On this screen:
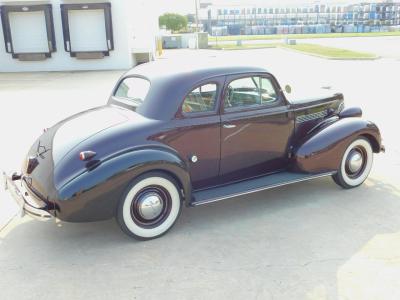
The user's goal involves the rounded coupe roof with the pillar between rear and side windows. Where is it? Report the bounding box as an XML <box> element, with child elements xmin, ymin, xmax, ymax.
<box><xmin>117</xmin><ymin>60</ymin><xmax>268</xmax><ymax>120</ymax></box>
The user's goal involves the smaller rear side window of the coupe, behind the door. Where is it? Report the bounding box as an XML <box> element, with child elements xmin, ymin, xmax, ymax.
<box><xmin>182</xmin><ymin>83</ymin><xmax>217</xmax><ymax>114</ymax></box>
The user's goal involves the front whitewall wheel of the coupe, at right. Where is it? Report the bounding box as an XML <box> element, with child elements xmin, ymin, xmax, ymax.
<box><xmin>333</xmin><ymin>137</ymin><xmax>374</xmax><ymax>189</ymax></box>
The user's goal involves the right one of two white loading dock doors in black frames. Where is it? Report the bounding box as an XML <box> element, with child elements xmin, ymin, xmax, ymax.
<box><xmin>68</xmin><ymin>9</ymin><xmax>108</xmax><ymax>52</ymax></box>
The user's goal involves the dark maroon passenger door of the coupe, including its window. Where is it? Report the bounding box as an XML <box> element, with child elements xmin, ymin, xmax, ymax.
<box><xmin>220</xmin><ymin>73</ymin><xmax>294</xmax><ymax>183</ymax></box>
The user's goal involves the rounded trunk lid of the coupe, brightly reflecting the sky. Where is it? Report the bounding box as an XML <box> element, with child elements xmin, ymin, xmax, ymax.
<box><xmin>22</xmin><ymin>106</ymin><xmax>129</xmax><ymax>204</ymax></box>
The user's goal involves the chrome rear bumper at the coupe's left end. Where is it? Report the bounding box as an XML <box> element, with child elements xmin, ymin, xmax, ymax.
<box><xmin>0</xmin><ymin>172</ymin><xmax>53</xmax><ymax>221</ymax></box>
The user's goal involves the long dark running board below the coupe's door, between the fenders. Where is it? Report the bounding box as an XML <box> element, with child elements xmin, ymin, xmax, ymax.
<box><xmin>190</xmin><ymin>172</ymin><xmax>336</xmax><ymax>206</ymax></box>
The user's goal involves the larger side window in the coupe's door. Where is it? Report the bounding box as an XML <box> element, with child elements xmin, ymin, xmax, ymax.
<box><xmin>224</xmin><ymin>76</ymin><xmax>278</xmax><ymax>110</ymax></box>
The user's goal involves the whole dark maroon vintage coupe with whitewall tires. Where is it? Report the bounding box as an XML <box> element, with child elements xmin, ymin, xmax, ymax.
<box><xmin>4</xmin><ymin>63</ymin><xmax>384</xmax><ymax>239</ymax></box>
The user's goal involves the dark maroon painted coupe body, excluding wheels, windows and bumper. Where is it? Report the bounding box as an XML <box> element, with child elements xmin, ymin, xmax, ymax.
<box><xmin>5</xmin><ymin>64</ymin><xmax>382</xmax><ymax>222</ymax></box>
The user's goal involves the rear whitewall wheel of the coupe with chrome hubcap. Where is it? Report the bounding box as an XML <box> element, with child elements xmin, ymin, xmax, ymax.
<box><xmin>117</xmin><ymin>172</ymin><xmax>182</xmax><ymax>240</ymax></box>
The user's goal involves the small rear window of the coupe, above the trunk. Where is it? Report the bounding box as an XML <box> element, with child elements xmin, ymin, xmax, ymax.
<box><xmin>114</xmin><ymin>77</ymin><xmax>150</xmax><ymax>106</ymax></box>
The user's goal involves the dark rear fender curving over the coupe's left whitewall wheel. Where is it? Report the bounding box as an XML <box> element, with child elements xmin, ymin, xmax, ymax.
<box><xmin>56</xmin><ymin>147</ymin><xmax>191</xmax><ymax>222</ymax></box>
